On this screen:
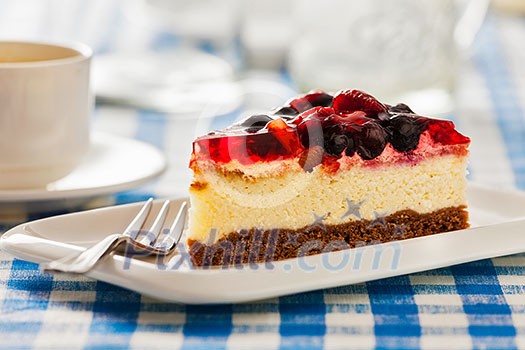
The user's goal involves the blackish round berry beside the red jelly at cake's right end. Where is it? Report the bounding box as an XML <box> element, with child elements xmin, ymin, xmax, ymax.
<box><xmin>387</xmin><ymin>114</ymin><xmax>427</xmax><ymax>152</ymax></box>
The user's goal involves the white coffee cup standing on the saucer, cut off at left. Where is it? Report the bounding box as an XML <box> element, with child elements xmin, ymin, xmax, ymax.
<box><xmin>0</xmin><ymin>41</ymin><xmax>92</xmax><ymax>190</ymax></box>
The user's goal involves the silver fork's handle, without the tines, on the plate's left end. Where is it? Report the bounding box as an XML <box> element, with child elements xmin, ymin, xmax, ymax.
<box><xmin>40</xmin><ymin>233</ymin><xmax>126</xmax><ymax>273</ymax></box>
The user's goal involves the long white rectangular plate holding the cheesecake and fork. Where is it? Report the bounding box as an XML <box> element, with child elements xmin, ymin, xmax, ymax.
<box><xmin>0</xmin><ymin>185</ymin><xmax>525</xmax><ymax>304</ymax></box>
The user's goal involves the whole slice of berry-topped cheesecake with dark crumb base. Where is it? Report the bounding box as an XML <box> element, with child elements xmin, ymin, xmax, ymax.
<box><xmin>188</xmin><ymin>90</ymin><xmax>470</xmax><ymax>266</ymax></box>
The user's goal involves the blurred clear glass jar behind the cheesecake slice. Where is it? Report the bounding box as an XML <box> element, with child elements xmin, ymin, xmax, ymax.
<box><xmin>288</xmin><ymin>0</ymin><xmax>489</xmax><ymax>114</ymax></box>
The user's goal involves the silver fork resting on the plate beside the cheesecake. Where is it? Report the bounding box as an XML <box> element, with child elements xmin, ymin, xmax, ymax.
<box><xmin>41</xmin><ymin>198</ymin><xmax>187</xmax><ymax>273</ymax></box>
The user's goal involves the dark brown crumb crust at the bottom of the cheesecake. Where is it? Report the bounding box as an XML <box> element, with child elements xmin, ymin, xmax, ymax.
<box><xmin>188</xmin><ymin>206</ymin><xmax>469</xmax><ymax>266</ymax></box>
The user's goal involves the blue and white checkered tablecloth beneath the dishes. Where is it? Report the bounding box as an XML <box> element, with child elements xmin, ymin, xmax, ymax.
<box><xmin>0</xmin><ymin>2</ymin><xmax>525</xmax><ymax>349</ymax></box>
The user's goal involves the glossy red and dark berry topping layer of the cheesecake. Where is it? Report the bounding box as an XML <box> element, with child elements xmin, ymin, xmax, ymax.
<box><xmin>192</xmin><ymin>90</ymin><xmax>470</xmax><ymax>171</ymax></box>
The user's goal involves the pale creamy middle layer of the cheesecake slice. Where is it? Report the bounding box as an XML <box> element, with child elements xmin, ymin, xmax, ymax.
<box><xmin>188</xmin><ymin>155</ymin><xmax>467</xmax><ymax>243</ymax></box>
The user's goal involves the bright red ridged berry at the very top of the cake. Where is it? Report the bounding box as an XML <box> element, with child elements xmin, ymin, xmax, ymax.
<box><xmin>333</xmin><ymin>90</ymin><xmax>387</xmax><ymax>118</ymax></box>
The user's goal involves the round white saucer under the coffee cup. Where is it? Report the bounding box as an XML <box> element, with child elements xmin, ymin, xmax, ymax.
<box><xmin>0</xmin><ymin>132</ymin><xmax>166</xmax><ymax>204</ymax></box>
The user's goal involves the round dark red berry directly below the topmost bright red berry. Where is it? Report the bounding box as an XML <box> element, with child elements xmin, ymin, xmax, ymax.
<box><xmin>354</xmin><ymin>121</ymin><xmax>388</xmax><ymax>160</ymax></box>
